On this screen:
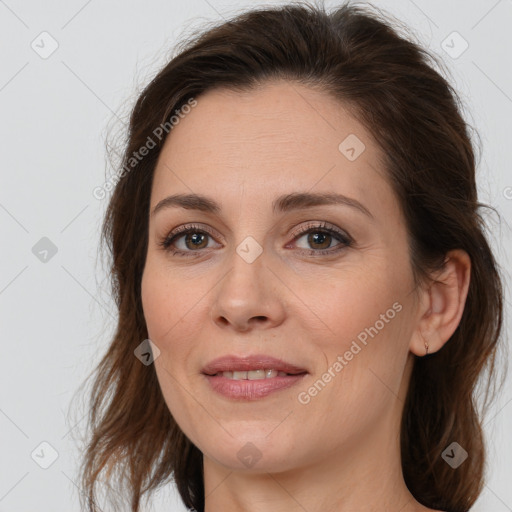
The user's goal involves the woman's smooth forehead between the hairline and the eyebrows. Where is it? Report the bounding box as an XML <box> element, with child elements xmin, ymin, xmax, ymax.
<box><xmin>151</xmin><ymin>81</ymin><xmax>393</xmax><ymax>217</ymax></box>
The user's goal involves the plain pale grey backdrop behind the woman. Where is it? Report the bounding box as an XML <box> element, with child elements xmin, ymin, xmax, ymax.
<box><xmin>0</xmin><ymin>0</ymin><xmax>512</xmax><ymax>512</ymax></box>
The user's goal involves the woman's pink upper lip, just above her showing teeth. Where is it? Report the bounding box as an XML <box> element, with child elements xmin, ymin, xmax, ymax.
<box><xmin>202</xmin><ymin>354</ymin><xmax>307</xmax><ymax>375</ymax></box>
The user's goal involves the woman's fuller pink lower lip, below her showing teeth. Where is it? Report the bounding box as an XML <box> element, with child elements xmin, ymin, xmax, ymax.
<box><xmin>205</xmin><ymin>373</ymin><xmax>307</xmax><ymax>400</ymax></box>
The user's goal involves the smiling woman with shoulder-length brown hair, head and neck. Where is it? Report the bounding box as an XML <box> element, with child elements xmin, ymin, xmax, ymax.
<box><xmin>78</xmin><ymin>4</ymin><xmax>502</xmax><ymax>512</ymax></box>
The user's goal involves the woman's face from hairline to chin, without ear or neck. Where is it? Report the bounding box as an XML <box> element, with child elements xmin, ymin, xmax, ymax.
<box><xmin>142</xmin><ymin>81</ymin><xmax>418</xmax><ymax>472</ymax></box>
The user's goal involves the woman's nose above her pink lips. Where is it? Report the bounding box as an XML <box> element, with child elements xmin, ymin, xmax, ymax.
<box><xmin>211</xmin><ymin>243</ymin><xmax>286</xmax><ymax>332</ymax></box>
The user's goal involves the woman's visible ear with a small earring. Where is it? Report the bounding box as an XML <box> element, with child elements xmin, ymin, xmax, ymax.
<box><xmin>409</xmin><ymin>249</ymin><xmax>471</xmax><ymax>356</ymax></box>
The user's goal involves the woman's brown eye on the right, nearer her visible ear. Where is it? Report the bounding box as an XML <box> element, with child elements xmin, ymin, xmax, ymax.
<box><xmin>288</xmin><ymin>222</ymin><xmax>353</xmax><ymax>256</ymax></box>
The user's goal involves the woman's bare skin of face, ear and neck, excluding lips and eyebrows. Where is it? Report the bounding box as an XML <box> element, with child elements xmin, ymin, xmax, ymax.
<box><xmin>142</xmin><ymin>81</ymin><xmax>470</xmax><ymax>512</ymax></box>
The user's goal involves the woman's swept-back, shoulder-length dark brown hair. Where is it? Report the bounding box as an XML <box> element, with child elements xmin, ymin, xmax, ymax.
<box><xmin>76</xmin><ymin>3</ymin><xmax>503</xmax><ymax>512</ymax></box>
